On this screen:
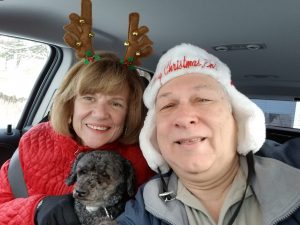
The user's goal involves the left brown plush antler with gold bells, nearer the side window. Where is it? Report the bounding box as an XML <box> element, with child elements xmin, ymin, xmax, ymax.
<box><xmin>64</xmin><ymin>0</ymin><xmax>94</xmax><ymax>58</ymax></box>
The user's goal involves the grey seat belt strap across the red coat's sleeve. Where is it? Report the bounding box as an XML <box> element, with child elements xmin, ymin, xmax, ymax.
<box><xmin>8</xmin><ymin>148</ymin><xmax>28</xmax><ymax>198</ymax></box>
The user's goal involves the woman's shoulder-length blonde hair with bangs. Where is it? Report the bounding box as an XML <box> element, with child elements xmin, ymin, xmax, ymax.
<box><xmin>50</xmin><ymin>52</ymin><xmax>146</xmax><ymax>144</ymax></box>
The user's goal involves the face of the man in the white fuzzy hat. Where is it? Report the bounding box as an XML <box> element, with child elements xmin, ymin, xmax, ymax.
<box><xmin>156</xmin><ymin>74</ymin><xmax>236</xmax><ymax>179</ymax></box>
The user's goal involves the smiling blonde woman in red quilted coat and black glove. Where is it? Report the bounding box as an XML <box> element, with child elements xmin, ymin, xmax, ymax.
<box><xmin>0</xmin><ymin>53</ymin><xmax>152</xmax><ymax>225</ymax></box>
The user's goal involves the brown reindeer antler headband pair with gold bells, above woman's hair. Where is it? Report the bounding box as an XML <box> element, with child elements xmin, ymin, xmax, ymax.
<box><xmin>64</xmin><ymin>0</ymin><xmax>153</xmax><ymax>68</ymax></box>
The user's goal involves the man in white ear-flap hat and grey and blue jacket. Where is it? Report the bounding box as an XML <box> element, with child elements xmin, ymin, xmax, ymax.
<box><xmin>117</xmin><ymin>44</ymin><xmax>300</xmax><ymax>225</ymax></box>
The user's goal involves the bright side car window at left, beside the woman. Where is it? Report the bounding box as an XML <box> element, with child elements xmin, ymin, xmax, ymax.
<box><xmin>0</xmin><ymin>35</ymin><xmax>51</xmax><ymax>128</ymax></box>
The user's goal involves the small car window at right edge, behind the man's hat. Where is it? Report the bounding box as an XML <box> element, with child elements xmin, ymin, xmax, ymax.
<box><xmin>252</xmin><ymin>99</ymin><xmax>300</xmax><ymax>129</ymax></box>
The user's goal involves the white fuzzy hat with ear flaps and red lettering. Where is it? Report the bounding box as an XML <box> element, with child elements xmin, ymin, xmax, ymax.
<box><xmin>140</xmin><ymin>43</ymin><xmax>266</xmax><ymax>173</ymax></box>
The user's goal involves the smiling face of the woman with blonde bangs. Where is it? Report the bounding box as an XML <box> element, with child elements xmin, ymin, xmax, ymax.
<box><xmin>72</xmin><ymin>90</ymin><xmax>129</xmax><ymax>148</ymax></box>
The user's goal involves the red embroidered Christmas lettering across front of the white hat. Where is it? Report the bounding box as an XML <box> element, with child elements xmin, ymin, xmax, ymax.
<box><xmin>156</xmin><ymin>56</ymin><xmax>217</xmax><ymax>80</ymax></box>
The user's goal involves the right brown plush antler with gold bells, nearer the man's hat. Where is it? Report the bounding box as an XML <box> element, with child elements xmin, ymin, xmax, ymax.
<box><xmin>124</xmin><ymin>12</ymin><xmax>153</xmax><ymax>66</ymax></box>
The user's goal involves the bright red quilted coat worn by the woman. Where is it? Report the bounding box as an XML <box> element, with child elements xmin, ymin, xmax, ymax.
<box><xmin>0</xmin><ymin>122</ymin><xmax>153</xmax><ymax>225</ymax></box>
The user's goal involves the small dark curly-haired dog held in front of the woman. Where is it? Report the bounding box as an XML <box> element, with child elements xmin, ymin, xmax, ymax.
<box><xmin>66</xmin><ymin>150</ymin><xmax>135</xmax><ymax>225</ymax></box>
